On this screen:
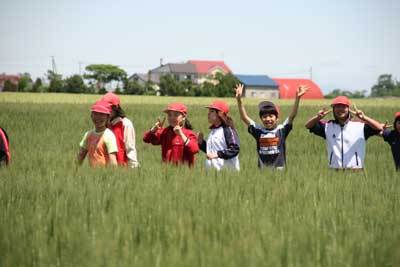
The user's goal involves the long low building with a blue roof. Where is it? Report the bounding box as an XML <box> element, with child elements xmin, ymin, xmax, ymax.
<box><xmin>235</xmin><ymin>74</ymin><xmax>279</xmax><ymax>99</ymax></box>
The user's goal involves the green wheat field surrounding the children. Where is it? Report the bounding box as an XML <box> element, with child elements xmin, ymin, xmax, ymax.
<box><xmin>0</xmin><ymin>93</ymin><xmax>400</xmax><ymax>266</ymax></box>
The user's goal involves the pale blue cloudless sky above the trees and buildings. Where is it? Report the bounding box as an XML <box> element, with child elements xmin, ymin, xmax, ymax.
<box><xmin>0</xmin><ymin>0</ymin><xmax>400</xmax><ymax>92</ymax></box>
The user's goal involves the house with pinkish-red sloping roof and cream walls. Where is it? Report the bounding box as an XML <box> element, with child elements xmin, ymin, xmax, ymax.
<box><xmin>188</xmin><ymin>60</ymin><xmax>232</xmax><ymax>84</ymax></box>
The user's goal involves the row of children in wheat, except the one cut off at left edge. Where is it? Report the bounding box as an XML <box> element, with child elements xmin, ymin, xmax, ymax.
<box><xmin>77</xmin><ymin>87</ymin><xmax>400</xmax><ymax>171</ymax></box>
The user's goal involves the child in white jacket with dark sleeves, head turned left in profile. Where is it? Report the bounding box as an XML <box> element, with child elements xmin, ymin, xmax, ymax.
<box><xmin>198</xmin><ymin>100</ymin><xmax>240</xmax><ymax>171</ymax></box>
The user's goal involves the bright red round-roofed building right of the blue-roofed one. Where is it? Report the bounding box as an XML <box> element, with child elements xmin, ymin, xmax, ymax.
<box><xmin>272</xmin><ymin>78</ymin><xmax>324</xmax><ymax>99</ymax></box>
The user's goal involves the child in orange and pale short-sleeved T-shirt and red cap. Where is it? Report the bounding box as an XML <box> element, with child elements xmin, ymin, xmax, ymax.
<box><xmin>77</xmin><ymin>101</ymin><xmax>118</xmax><ymax>167</ymax></box>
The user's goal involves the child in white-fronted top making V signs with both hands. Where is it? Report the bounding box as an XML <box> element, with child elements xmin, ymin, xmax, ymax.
<box><xmin>306</xmin><ymin>96</ymin><xmax>382</xmax><ymax>170</ymax></box>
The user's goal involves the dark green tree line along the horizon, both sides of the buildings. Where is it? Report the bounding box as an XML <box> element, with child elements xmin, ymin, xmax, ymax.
<box><xmin>3</xmin><ymin>64</ymin><xmax>400</xmax><ymax>98</ymax></box>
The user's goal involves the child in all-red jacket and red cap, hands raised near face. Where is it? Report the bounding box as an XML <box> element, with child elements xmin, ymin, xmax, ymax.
<box><xmin>143</xmin><ymin>103</ymin><xmax>199</xmax><ymax>166</ymax></box>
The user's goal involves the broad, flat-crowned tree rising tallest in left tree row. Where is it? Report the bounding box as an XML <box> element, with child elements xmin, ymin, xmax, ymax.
<box><xmin>83</xmin><ymin>64</ymin><xmax>127</xmax><ymax>91</ymax></box>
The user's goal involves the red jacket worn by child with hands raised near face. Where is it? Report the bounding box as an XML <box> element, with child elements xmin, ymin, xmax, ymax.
<box><xmin>143</xmin><ymin>127</ymin><xmax>199</xmax><ymax>166</ymax></box>
